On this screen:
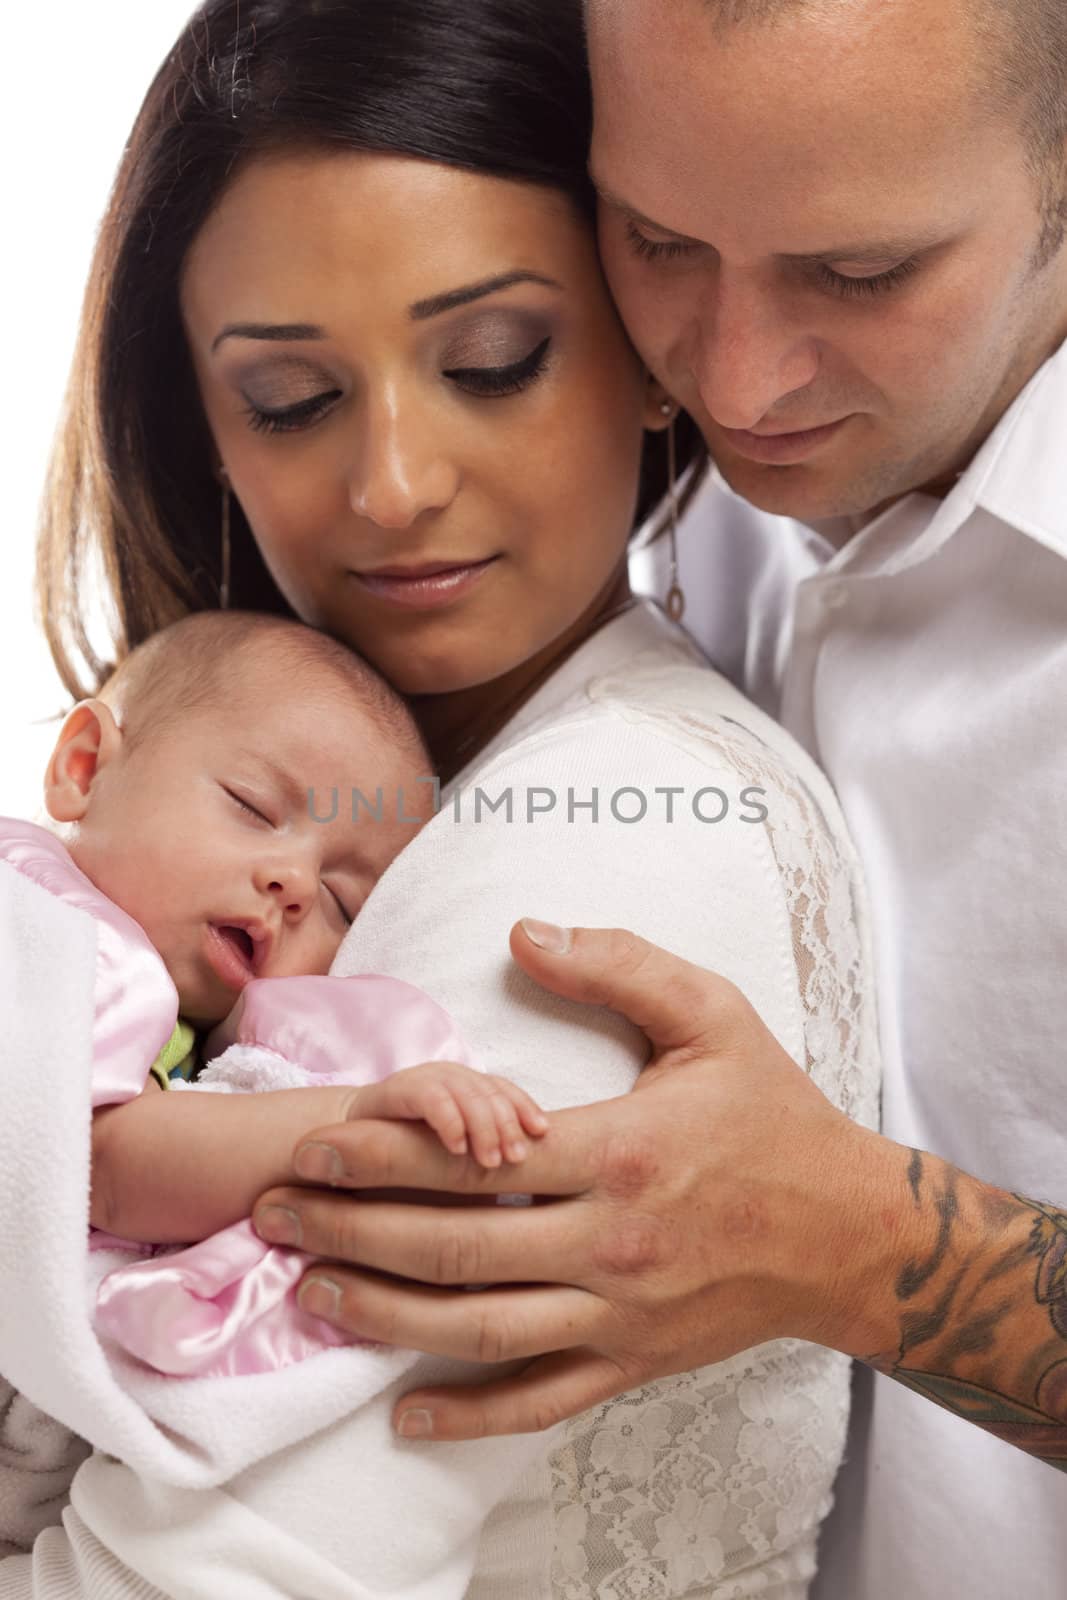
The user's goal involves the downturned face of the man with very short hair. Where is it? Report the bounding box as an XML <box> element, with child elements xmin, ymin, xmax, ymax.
<box><xmin>589</xmin><ymin>0</ymin><xmax>1067</xmax><ymax>520</ymax></box>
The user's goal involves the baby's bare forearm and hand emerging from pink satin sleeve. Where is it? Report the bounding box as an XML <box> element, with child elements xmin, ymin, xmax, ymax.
<box><xmin>90</xmin><ymin>1064</ymin><xmax>547</xmax><ymax>1245</ymax></box>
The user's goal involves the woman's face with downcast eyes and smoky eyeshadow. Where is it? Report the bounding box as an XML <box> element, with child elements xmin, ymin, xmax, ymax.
<box><xmin>182</xmin><ymin>154</ymin><xmax>662</xmax><ymax>694</ymax></box>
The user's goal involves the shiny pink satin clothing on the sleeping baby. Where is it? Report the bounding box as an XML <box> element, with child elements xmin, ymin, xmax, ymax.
<box><xmin>0</xmin><ymin>818</ymin><xmax>469</xmax><ymax>1378</ymax></box>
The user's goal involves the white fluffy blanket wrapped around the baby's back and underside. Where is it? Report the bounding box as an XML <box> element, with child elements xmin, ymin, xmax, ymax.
<box><xmin>0</xmin><ymin>866</ymin><xmax>425</xmax><ymax>1488</ymax></box>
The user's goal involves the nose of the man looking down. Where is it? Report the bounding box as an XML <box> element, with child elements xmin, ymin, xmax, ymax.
<box><xmin>689</xmin><ymin>267</ymin><xmax>819</xmax><ymax>429</ymax></box>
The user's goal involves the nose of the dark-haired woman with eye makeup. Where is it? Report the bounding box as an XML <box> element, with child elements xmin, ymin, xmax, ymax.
<box><xmin>349</xmin><ymin>397</ymin><xmax>459</xmax><ymax>531</ymax></box>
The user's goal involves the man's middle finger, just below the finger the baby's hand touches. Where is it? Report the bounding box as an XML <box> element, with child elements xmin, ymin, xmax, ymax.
<box><xmin>253</xmin><ymin>1189</ymin><xmax>584</xmax><ymax>1286</ymax></box>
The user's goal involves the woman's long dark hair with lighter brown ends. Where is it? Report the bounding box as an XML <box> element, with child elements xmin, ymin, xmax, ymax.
<box><xmin>38</xmin><ymin>0</ymin><xmax>704</xmax><ymax>696</ymax></box>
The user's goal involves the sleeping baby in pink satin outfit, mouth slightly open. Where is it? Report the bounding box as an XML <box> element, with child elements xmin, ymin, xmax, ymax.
<box><xmin>0</xmin><ymin>613</ymin><xmax>547</xmax><ymax>1555</ymax></box>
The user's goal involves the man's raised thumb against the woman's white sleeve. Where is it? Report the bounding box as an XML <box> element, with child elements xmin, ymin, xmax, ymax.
<box><xmin>510</xmin><ymin>918</ymin><xmax>741</xmax><ymax>1053</ymax></box>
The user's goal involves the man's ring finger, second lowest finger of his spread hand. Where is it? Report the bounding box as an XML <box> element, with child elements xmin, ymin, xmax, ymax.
<box><xmin>299</xmin><ymin>1262</ymin><xmax>603</xmax><ymax>1363</ymax></box>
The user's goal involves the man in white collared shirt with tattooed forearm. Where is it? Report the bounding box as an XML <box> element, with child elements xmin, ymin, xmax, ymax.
<box><xmin>258</xmin><ymin>0</ymin><xmax>1067</xmax><ymax>1600</ymax></box>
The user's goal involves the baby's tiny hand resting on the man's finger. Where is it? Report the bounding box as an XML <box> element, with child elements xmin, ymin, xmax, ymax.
<box><xmin>349</xmin><ymin>1062</ymin><xmax>549</xmax><ymax>1166</ymax></box>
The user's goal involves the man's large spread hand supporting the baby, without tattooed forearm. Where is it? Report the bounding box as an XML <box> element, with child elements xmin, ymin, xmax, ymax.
<box><xmin>254</xmin><ymin>923</ymin><xmax>907</xmax><ymax>1438</ymax></box>
